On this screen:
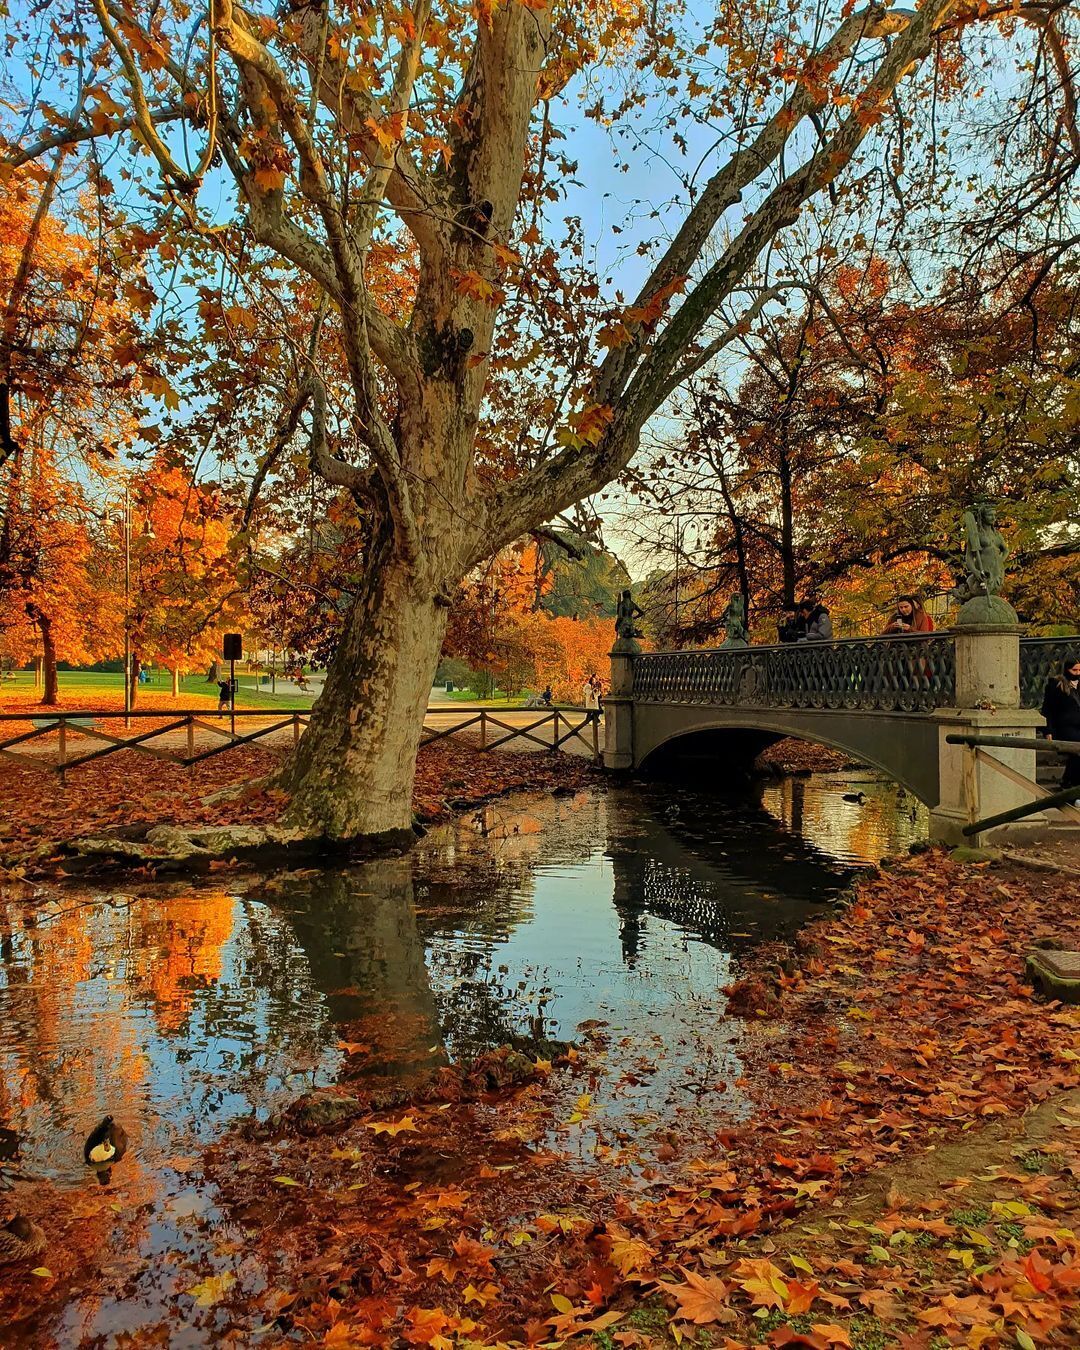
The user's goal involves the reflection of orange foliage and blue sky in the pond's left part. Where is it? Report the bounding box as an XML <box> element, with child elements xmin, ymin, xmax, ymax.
<box><xmin>0</xmin><ymin>891</ymin><xmax>340</xmax><ymax>1180</ymax></box>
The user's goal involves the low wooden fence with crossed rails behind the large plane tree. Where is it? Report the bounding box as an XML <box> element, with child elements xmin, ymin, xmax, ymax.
<box><xmin>0</xmin><ymin>705</ymin><xmax>601</xmax><ymax>779</ymax></box>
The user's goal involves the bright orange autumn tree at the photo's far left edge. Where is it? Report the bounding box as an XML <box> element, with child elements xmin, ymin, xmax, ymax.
<box><xmin>0</xmin><ymin>162</ymin><xmax>147</xmax><ymax>703</ymax></box>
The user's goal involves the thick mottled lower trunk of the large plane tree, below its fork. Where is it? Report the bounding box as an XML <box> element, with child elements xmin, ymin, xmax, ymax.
<box><xmin>278</xmin><ymin>545</ymin><xmax>447</xmax><ymax>844</ymax></box>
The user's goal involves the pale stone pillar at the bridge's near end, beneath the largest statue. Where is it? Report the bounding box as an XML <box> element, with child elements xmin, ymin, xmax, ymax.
<box><xmin>930</xmin><ymin>621</ymin><xmax>1046</xmax><ymax>845</ymax></box>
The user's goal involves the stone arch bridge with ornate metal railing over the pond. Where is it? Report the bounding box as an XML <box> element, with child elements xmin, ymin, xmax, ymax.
<box><xmin>605</xmin><ymin>628</ymin><xmax>1076</xmax><ymax>841</ymax></box>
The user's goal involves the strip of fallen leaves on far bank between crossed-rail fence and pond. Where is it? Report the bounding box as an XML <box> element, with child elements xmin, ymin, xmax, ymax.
<box><xmin>0</xmin><ymin>738</ymin><xmax>598</xmax><ymax>876</ymax></box>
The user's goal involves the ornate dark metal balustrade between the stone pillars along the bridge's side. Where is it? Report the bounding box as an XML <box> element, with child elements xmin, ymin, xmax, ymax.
<box><xmin>633</xmin><ymin>633</ymin><xmax>956</xmax><ymax>713</ymax></box>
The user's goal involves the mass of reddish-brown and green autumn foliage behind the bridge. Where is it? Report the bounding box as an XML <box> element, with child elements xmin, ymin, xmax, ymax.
<box><xmin>636</xmin><ymin>257</ymin><xmax>1080</xmax><ymax>639</ymax></box>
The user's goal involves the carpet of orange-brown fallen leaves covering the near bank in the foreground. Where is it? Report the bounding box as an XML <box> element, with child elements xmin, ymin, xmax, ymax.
<box><xmin>0</xmin><ymin>852</ymin><xmax>1080</xmax><ymax>1350</ymax></box>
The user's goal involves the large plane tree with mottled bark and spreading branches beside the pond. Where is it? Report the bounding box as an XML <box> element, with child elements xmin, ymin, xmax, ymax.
<box><xmin>8</xmin><ymin>0</ymin><xmax>1076</xmax><ymax>838</ymax></box>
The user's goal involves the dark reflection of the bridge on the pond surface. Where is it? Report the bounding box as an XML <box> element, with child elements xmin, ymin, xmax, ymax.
<box><xmin>606</xmin><ymin>788</ymin><xmax>848</xmax><ymax>967</ymax></box>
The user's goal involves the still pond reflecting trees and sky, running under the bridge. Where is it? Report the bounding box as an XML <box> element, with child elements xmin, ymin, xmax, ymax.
<box><xmin>0</xmin><ymin>775</ymin><xmax>925</xmax><ymax>1345</ymax></box>
